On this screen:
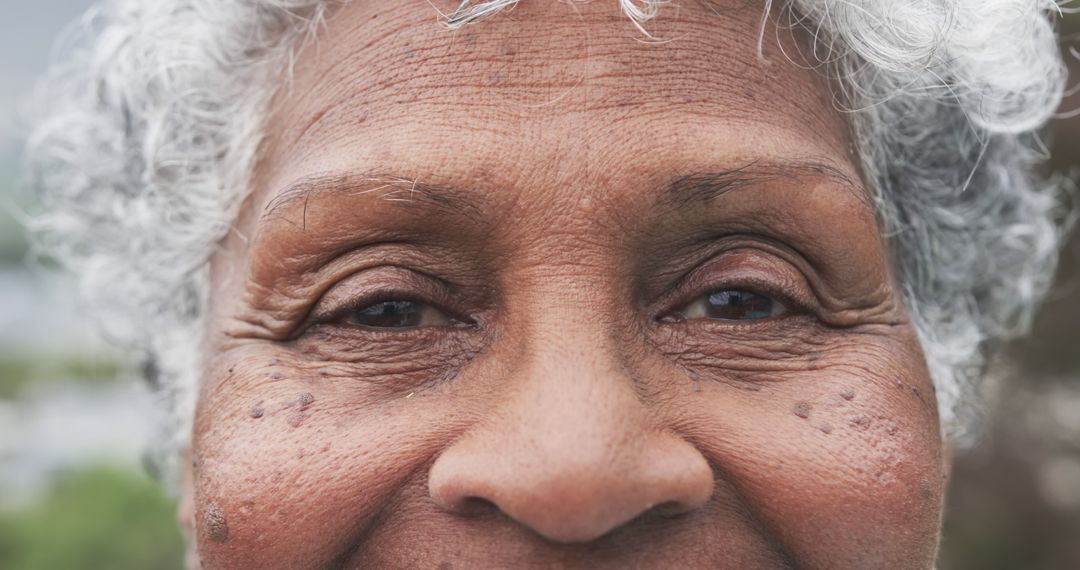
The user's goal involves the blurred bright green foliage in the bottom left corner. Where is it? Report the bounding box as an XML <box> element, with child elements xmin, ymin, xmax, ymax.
<box><xmin>0</xmin><ymin>467</ymin><xmax>184</xmax><ymax>570</ymax></box>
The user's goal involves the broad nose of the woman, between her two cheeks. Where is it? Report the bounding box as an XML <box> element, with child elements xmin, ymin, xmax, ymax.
<box><xmin>428</xmin><ymin>338</ymin><xmax>714</xmax><ymax>543</ymax></box>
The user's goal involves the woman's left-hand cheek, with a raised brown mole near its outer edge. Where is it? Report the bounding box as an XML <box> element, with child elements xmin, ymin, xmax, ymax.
<box><xmin>192</xmin><ymin>352</ymin><xmax>449</xmax><ymax>568</ymax></box>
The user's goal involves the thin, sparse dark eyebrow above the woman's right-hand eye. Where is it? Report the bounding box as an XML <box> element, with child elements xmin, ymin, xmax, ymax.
<box><xmin>661</xmin><ymin>161</ymin><xmax>872</xmax><ymax>209</ymax></box>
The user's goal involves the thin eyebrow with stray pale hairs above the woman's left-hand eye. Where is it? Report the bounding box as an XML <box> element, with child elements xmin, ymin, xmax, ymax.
<box><xmin>260</xmin><ymin>173</ymin><xmax>482</xmax><ymax>229</ymax></box>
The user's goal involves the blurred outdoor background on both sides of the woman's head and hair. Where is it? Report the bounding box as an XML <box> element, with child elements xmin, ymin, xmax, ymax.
<box><xmin>0</xmin><ymin>0</ymin><xmax>1080</xmax><ymax>570</ymax></box>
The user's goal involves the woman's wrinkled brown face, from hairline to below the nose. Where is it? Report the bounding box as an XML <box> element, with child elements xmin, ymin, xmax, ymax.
<box><xmin>186</xmin><ymin>0</ymin><xmax>946</xmax><ymax>569</ymax></box>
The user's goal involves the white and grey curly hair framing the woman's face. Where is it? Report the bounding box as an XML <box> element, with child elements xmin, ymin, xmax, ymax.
<box><xmin>28</xmin><ymin>0</ymin><xmax>1066</xmax><ymax>479</ymax></box>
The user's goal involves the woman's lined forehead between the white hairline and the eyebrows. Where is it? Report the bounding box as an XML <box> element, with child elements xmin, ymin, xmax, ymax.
<box><xmin>259</xmin><ymin>0</ymin><xmax>858</xmax><ymax>201</ymax></box>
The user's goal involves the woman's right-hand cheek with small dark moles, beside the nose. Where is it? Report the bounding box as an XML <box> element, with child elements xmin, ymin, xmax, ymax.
<box><xmin>678</xmin><ymin>336</ymin><xmax>945</xmax><ymax>568</ymax></box>
